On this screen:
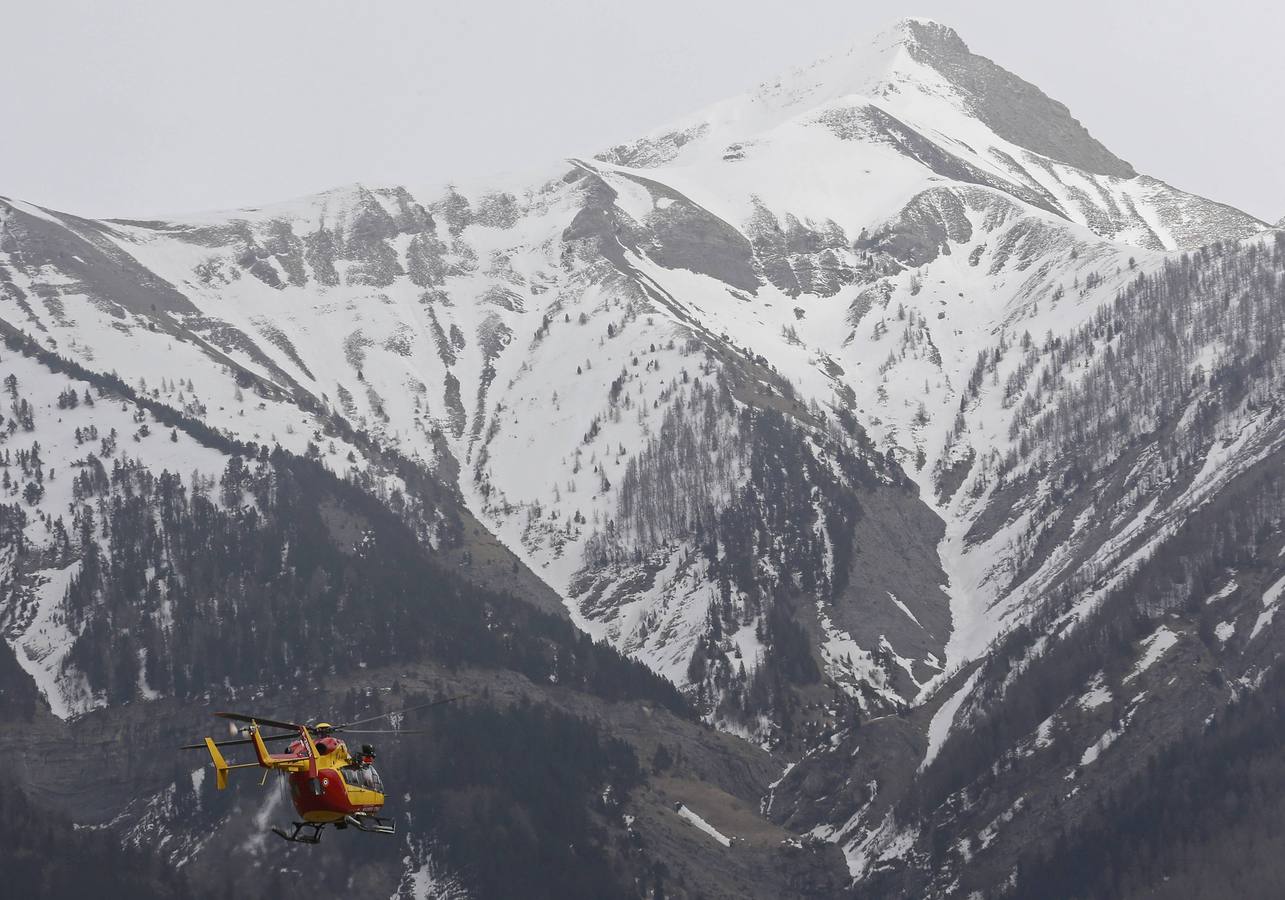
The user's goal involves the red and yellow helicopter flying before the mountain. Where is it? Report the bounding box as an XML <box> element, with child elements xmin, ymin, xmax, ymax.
<box><xmin>180</xmin><ymin>697</ymin><xmax>463</xmax><ymax>843</ymax></box>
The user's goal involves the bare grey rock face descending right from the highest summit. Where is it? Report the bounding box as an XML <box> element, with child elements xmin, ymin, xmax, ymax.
<box><xmin>907</xmin><ymin>22</ymin><xmax>1137</xmax><ymax>179</ymax></box>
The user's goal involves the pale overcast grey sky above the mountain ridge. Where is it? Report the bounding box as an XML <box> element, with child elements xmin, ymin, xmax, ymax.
<box><xmin>0</xmin><ymin>0</ymin><xmax>1285</xmax><ymax>221</ymax></box>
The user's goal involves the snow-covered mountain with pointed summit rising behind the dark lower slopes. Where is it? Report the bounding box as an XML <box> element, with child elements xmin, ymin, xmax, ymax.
<box><xmin>0</xmin><ymin>19</ymin><xmax>1285</xmax><ymax>892</ymax></box>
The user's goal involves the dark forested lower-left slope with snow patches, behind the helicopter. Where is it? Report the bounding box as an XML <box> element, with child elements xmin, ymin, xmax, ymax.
<box><xmin>0</xmin><ymin>337</ymin><xmax>840</xmax><ymax>896</ymax></box>
